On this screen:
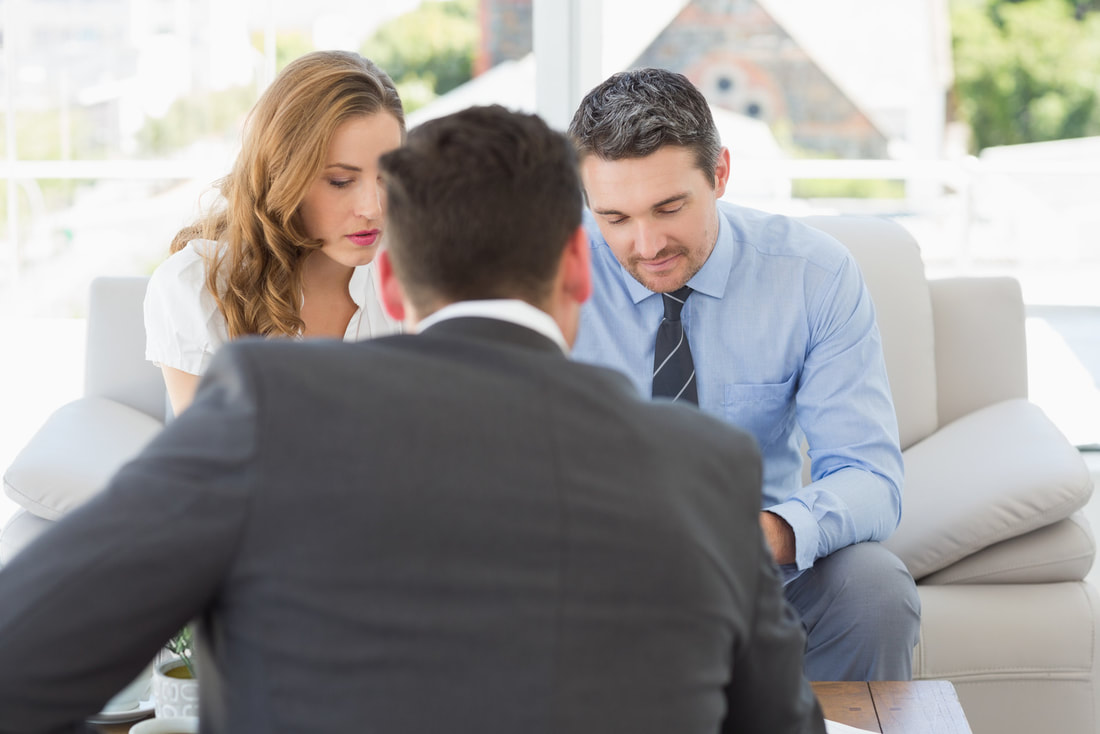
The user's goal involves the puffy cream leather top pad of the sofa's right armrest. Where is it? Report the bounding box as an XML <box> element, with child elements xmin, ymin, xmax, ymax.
<box><xmin>886</xmin><ymin>399</ymin><xmax>1092</xmax><ymax>579</ymax></box>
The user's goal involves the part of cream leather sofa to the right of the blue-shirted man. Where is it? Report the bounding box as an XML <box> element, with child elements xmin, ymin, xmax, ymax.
<box><xmin>805</xmin><ymin>217</ymin><xmax>1100</xmax><ymax>734</ymax></box>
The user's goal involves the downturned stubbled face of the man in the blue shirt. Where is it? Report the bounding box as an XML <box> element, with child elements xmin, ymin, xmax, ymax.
<box><xmin>581</xmin><ymin>145</ymin><xmax>729</xmax><ymax>293</ymax></box>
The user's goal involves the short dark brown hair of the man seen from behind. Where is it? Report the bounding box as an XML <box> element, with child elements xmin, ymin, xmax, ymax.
<box><xmin>380</xmin><ymin>106</ymin><xmax>583</xmax><ymax>315</ymax></box>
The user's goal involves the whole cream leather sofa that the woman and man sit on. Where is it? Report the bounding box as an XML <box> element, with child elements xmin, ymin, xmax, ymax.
<box><xmin>0</xmin><ymin>217</ymin><xmax>1100</xmax><ymax>734</ymax></box>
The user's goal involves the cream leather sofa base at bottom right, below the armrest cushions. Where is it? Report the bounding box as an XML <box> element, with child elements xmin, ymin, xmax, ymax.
<box><xmin>913</xmin><ymin>581</ymin><xmax>1100</xmax><ymax>732</ymax></box>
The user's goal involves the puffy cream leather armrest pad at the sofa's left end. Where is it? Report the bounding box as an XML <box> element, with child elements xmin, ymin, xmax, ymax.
<box><xmin>3</xmin><ymin>397</ymin><xmax>163</xmax><ymax>519</ymax></box>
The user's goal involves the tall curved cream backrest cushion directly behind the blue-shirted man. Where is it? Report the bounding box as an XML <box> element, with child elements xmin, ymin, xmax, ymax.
<box><xmin>802</xmin><ymin>216</ymin><xmax>939</xmax><ymax>449</ymax></box>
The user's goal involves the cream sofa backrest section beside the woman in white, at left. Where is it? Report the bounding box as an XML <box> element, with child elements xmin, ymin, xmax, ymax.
<box><xmin>84</xmin><ymin>276</ymin><xmax>166</xmax><ymax>420</ymax></box>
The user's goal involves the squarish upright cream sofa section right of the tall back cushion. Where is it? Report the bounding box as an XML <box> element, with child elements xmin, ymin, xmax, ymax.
<box><xmin>928</xmin><ymin>277</ymin><xmax>1027</xmax><ymax>426</ymax></box>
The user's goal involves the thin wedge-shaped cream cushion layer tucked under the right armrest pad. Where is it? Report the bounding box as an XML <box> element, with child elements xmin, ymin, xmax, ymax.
<box><xmin>921</xmin><ymin>512</ymin><xmax>1096</xmax><ymax>584</ymax></box>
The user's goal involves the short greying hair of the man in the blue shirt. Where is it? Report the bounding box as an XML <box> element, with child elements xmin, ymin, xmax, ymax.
<box><xmin>569</xmin><ymin>68</ymin><xmax>722</xmax><ymax>177</ymax></box>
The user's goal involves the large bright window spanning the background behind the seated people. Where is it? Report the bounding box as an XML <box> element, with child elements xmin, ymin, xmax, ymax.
<box><xmin>0</xmin><ymin>0</ymin><xmax>1100</xmax><ymax>517</ymax></box>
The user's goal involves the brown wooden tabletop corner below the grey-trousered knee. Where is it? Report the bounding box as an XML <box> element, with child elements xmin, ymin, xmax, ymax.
<box><xmin>812</xmin><ymin>680</ymin><xmax>971</xmax><ymax>734</ymax></box>
